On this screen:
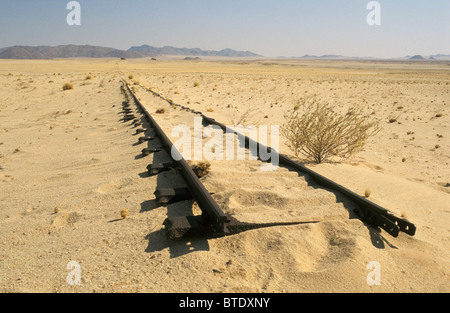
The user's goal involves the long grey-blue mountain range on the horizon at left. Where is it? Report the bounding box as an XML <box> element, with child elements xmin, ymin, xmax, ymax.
<box><xmin>0</xmin><ymin>45</ymin><xmax>260</xmax><ymax>59</ymax></box>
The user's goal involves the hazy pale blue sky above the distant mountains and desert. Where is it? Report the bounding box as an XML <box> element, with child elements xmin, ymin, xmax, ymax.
<box><xmin>0</xmin><ymin>0</ymin><xmax>450</xmax><ymax>57</ymax></box>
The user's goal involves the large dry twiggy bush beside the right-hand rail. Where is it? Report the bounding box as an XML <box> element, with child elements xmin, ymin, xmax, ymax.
<box><xmin>281</xmin><ymin>96</ymin><xmax>380</xmax><ymax>163</ymax></box>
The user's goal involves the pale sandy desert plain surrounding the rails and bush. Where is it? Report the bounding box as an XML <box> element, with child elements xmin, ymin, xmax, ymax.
<box><xmin>0</xmin><ymin>59</ymin><xmax>450</xmax><ymax>293</ymax></box>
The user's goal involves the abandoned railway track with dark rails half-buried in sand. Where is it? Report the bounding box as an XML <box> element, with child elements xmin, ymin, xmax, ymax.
<box><xmin>121</xmin><ymin>81</ymin><xmax>416</xmax><ymax>239</ymax></box>
